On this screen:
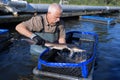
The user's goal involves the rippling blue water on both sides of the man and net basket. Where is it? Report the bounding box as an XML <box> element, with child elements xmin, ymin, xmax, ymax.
<box><xmin>0</xmin><ymin>20</ymin><xmax>120</xmax><ymax>80</ymax></box>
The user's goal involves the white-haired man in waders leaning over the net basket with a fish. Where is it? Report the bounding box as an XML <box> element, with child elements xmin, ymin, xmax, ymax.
<box><xmin>16</xmin><ymin>3</ymin><xmax>66</xmax><ymax>54</ymax></box>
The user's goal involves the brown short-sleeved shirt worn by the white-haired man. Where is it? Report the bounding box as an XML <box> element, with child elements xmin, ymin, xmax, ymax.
<box><xmin>22</xmin><ymin>15</ymin><xmax>65</xmax><ymax>38</ymax></box>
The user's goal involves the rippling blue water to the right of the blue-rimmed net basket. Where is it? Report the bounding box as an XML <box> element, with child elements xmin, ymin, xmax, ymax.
<box><xmin>67</xmin><ymin>19</ymin><xmax>120</xmax><ymax>80</ymax></box>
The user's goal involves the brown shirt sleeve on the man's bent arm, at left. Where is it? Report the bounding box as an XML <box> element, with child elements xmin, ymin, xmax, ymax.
<box><xmin>22</xmin><ymin>16</ymin><xmax>43</xmax><ymax>31</ymax></box>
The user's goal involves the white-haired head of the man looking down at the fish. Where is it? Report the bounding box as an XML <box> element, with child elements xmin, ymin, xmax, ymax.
<box><xmin>47</xmin><ymin>3</ymin><xmax>62</xmax><ymax>25</ymax></box>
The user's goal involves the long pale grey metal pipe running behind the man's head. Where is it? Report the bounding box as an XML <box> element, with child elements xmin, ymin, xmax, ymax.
<box><xmin>26</xmin><ymin>4</ymin><xmax>120</xmax><ymax>12</ymax></box>
